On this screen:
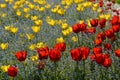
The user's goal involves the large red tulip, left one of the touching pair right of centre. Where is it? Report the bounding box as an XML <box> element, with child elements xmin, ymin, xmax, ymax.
<box><xmin>70</xmin><ymin>48</ymin><xmax>82</xmax><ymax>61</ymax></box>
